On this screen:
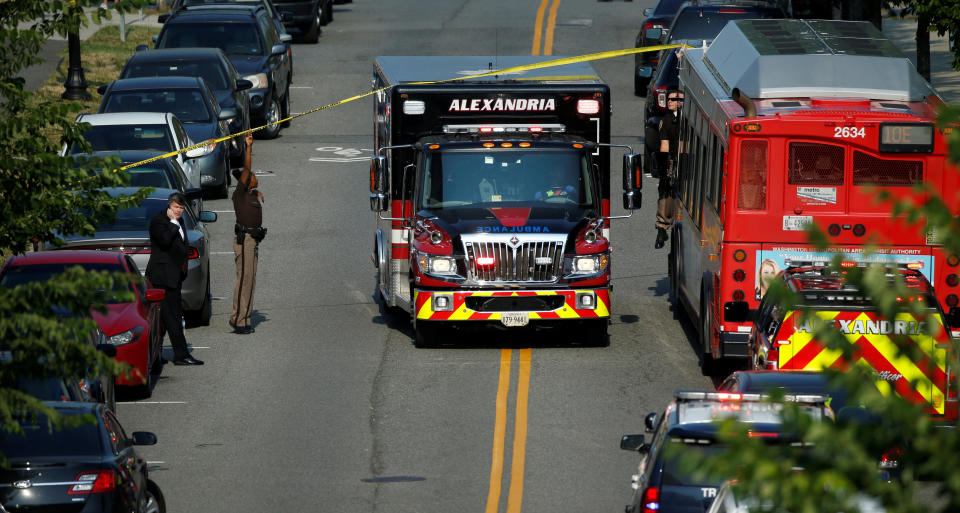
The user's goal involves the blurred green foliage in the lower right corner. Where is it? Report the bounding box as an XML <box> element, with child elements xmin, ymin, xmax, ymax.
<box><xmin>686</xmin><ymin>106</ymin><xmax>960</xmax><ymax>513</ymax></box>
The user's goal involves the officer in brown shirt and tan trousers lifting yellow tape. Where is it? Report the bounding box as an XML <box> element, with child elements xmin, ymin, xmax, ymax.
<box><xmin>230</xmin><ymin>132</ymin><xmax>267</xmax><ymax>335</ymax></box>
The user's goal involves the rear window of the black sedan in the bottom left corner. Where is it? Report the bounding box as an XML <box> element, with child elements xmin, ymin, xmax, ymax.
<box><xmin>0</xmin><ymin>412</ymin><xmax>102</xmax><ymax>459</ymax></box>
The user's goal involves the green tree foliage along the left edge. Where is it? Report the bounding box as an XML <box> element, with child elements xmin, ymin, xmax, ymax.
<box><xmin>0</xmin><ymin>0</ymin><xmax>147</xmax><ymax>430</ymax></box>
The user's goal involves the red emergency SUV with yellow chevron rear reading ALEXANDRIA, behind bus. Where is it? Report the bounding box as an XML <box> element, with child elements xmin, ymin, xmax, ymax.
<box><xmin>749</xmin><ymin>262</ymin><xmax>957</xmax><ymax>420</ymax></box>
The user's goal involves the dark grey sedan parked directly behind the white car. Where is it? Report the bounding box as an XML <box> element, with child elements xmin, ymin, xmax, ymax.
<box><xmin>97</xmin><ymin>76</ymin><xmax>238</xmax><ymax>198</ymax></box>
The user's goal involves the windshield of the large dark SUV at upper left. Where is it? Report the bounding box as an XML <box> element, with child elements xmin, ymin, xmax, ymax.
<box><xmin>157</xmin><ymin>21</ymin><xmax>264</xmax><ymax>55</ymax></box>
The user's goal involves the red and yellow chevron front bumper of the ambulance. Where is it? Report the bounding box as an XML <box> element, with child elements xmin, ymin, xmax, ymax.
<box><xmin>414</xmin><ymin>288</ymin><xmax>610</xmax><ymax>327</ymax></box>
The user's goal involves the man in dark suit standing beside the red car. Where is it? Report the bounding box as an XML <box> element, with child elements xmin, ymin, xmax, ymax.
<box><xmin>147</xmin><ymin>192</ymin><xmax>203</xmax><ymax>365</ymax></box>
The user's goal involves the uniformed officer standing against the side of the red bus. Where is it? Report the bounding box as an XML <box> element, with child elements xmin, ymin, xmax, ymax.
<box><xmin>653</xmin><ymin>91</ymin><xmax>683</xmax><ymax>249</ymax></box>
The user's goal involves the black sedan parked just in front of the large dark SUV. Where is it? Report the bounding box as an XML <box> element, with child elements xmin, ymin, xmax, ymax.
<box><xmin>119</xmin><ymin>45</ymin><xmax>253</xmax><ymax>165</ymax></box>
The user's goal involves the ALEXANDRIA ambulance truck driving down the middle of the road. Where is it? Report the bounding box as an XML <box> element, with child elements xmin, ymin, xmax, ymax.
<box><xmin>370</xmin><ymin>57</ymin><xmax>641</xmax><ymax>347</ymax></box>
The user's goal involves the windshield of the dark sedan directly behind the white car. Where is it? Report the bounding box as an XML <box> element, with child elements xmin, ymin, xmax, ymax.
<box><xmin>100</xmin><ymin>89</ymin><xmax>212</xmax><ymax>123</ymax></box>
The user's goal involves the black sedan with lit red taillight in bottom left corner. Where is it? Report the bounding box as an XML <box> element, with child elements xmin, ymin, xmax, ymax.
<box><xmin>0</xmin><ymin>402</ymin><xmax>166</xmax><ymax>513</ymax></box>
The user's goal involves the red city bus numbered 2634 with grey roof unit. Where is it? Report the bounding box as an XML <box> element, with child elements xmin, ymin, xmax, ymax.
<box><xmin>669</xmin><ymin>20</ymin><xmax>960</xmax><ymax>372</ymax></box>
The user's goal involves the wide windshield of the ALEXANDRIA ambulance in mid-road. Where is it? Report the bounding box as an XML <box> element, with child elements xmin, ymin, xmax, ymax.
<box><xmin>419</xmin><ymin>149</ymin><xmax>596</xmax><ymax>209</ymax></box>
